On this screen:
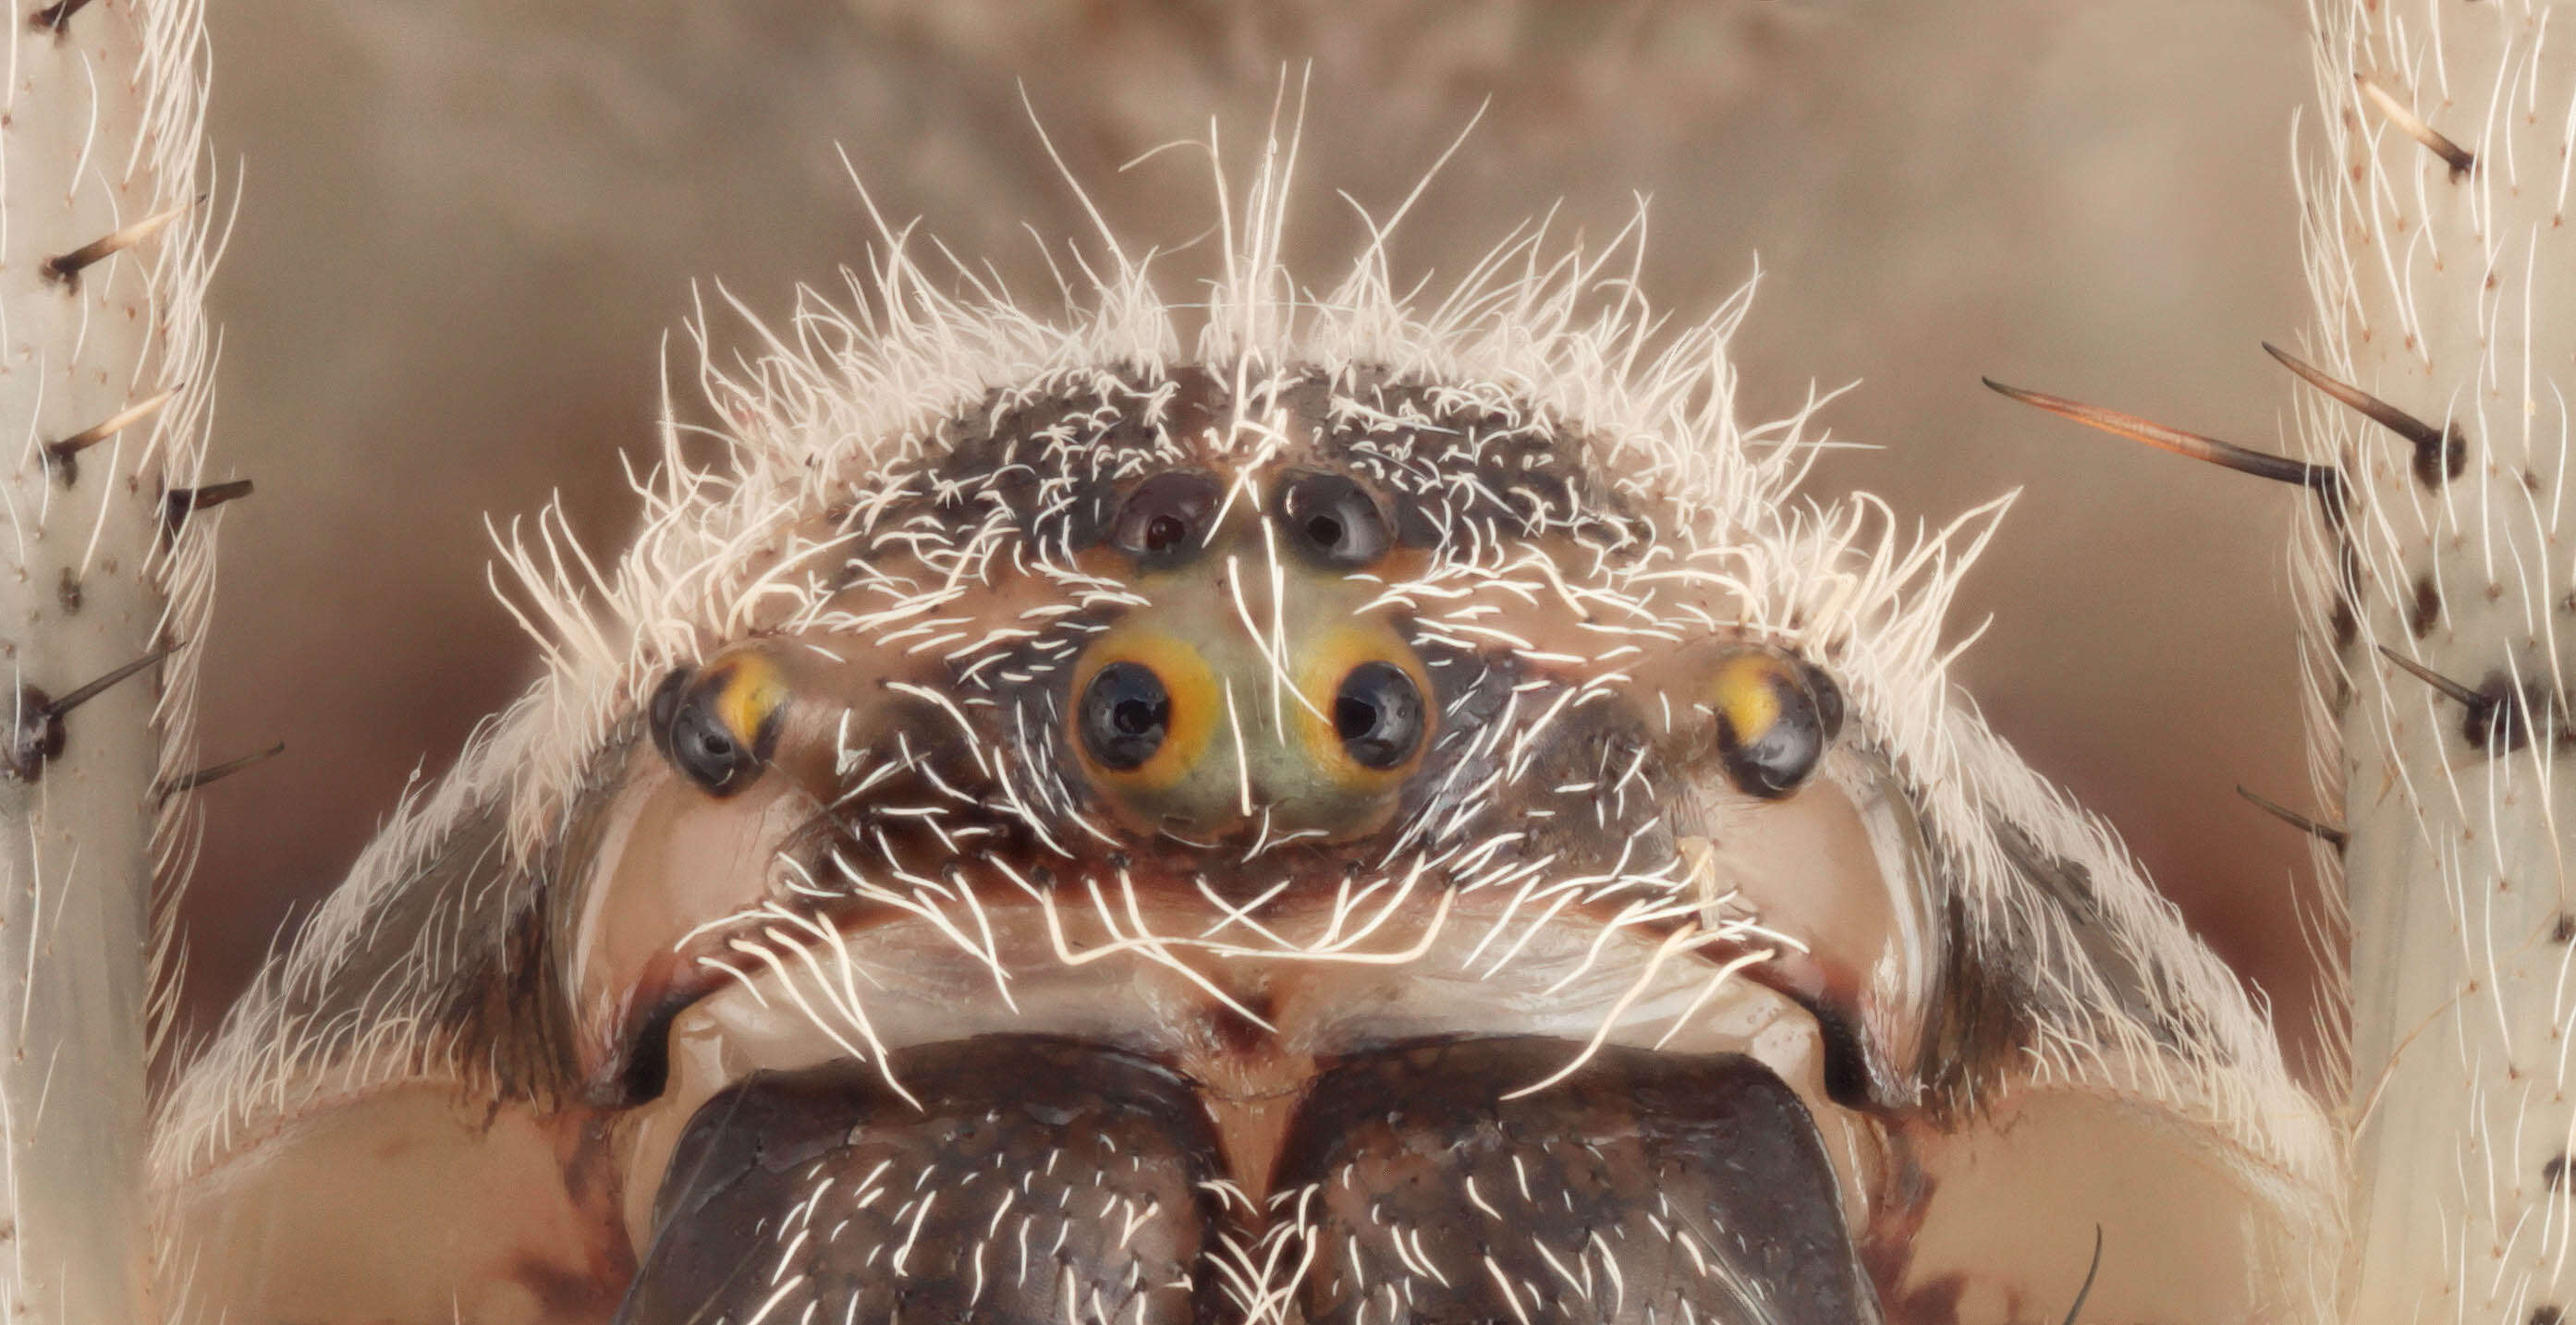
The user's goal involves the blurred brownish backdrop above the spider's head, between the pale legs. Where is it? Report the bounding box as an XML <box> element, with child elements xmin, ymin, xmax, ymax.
<box><xmin>186</xmin><ymin>0</ymin><xmax>2314</xmax><ymax>1080</ymax></box>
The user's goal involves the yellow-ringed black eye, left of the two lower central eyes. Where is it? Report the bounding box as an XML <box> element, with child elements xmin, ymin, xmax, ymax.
<box><xmin>1069</xmin><ymin>627</ymin><xmax>1224</xmax><ymax>793</ymax></box>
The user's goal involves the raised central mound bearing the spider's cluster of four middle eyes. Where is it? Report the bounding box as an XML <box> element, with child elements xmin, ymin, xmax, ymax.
<box><xmin>1051</xmin><ymin>468</ymin><xmax>1440</xmax><ymax>846</ymax></box>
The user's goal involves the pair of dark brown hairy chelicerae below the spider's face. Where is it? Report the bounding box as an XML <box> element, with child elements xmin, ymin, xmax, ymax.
<box><xmin>616</xmin><ymin>1034</ymin><xmax>1878</xmax><ymax>1325</ymax></box>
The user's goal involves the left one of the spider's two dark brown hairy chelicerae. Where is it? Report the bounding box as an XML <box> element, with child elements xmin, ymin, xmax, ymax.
<box><xmin>616</xmin><ymin>1034</ymin><xmax>1227</xmax><ymax>1325</ymax></box>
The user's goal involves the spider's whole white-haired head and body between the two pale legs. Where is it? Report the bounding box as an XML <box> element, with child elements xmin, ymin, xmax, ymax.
<box><xmin>154</xmin><ymin>155</ymin><xmax>2337</xmax><ymax>1325</ymax></box>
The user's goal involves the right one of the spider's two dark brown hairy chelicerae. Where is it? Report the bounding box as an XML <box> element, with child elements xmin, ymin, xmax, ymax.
<box><xmin>1277</xmin><ymin>1039</ymin><xmax>1878</xmax><ymax>1325</ymax></box>
